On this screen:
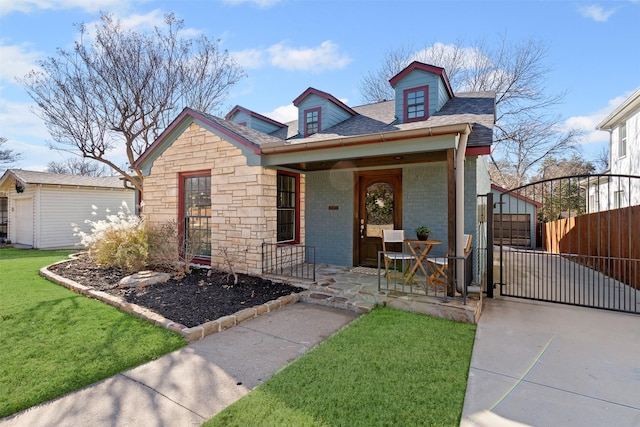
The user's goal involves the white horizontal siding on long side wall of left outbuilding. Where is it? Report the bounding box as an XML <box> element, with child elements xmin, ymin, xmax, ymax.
<box><xmin>36</xmin><ymin>185</ymin><xmax>135</xmax><ymax>249</ymax></box>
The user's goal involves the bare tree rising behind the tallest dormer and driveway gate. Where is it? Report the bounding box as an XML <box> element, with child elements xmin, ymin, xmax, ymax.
<box><xmin>360</xmin><ymin>36</ymin><xmax>580</xmax><ymax>188</ymax></box>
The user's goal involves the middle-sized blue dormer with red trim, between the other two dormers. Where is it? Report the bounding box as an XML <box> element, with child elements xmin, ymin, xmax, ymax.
<box><xmin>293</xmin><ymin>87</ymin><xmax>358</xmax><ymax>137</ymax></box>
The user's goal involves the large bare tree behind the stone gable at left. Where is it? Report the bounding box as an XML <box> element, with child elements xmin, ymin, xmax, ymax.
<box><xmin>21</xmin><ymin>14</ymin><xmax>244</xmax><ymax>189</ymax></box>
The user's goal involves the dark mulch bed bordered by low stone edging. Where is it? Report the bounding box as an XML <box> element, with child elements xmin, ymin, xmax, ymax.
<box><xmin>49</xmin><ymin>254</ymin><xmax>304</xmax><ymax>327</ymax></box>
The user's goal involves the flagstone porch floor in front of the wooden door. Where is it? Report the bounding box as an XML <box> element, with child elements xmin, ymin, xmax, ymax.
<box><xmin>265</xmin><ymin>264</ymin><xmax>482</xmax><ymax>324</ymax></box>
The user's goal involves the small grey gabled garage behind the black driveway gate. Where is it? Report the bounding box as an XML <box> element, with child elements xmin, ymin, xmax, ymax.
<box><xmin>491</xmin><ymin>184</ymin><xmax>542</xmax><ymax>248</ymax></box>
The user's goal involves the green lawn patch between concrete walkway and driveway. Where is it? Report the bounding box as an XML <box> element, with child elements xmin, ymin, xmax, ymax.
<box><xmin>205</xmin><ymin>308</ymin><xmax>475</xmax><ymax>427</ymax></box>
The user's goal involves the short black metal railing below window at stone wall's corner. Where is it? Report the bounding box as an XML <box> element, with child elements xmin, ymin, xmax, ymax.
<box><xmin>262</xmin><ymin>243</ymin><xmax>316</xmax><ymax>281</ymax></box>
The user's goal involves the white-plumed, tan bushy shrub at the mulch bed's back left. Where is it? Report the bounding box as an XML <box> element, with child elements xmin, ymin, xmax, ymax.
<box><xmin>72</xmin><ymin>202</ymin><xmax>149</xmax><ymax>272</ymax></box>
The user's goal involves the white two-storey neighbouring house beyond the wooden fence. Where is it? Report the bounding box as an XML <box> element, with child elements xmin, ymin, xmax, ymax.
<box><xmin>587</xmin><ymin>89</ymin><xmax>640</xmax><ymax>212</ymax></box>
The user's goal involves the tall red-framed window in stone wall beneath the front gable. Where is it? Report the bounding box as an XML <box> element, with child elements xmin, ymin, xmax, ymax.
<box><xmin>180</xmin><ymin>172</ymin><xmax>211</xmax><ymax>259</ymax></box>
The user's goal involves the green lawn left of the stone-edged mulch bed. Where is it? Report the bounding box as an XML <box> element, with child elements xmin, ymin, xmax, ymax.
<box><xmin>0</xmin><ymin>248</ymin><xmax>186</xmax><ymax>417</ymax></box>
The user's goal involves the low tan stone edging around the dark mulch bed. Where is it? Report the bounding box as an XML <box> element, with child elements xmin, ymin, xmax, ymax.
<box><xmin>40</xmin><ymin>260</ymin><xmax>300</xmax><ymax>343</ymax></box>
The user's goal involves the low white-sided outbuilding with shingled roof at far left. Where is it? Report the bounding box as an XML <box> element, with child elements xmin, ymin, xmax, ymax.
<box><xmin>0</xmin><ymin>169</ymin><xmax>135</xmax><ymax>249</ymax></box>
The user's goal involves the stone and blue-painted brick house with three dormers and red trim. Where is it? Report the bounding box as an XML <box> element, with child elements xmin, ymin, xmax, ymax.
<box><xmin>135</xmin><ymin>62</ymin><xmax>495</xmax><ymax>284</ymax></box>
